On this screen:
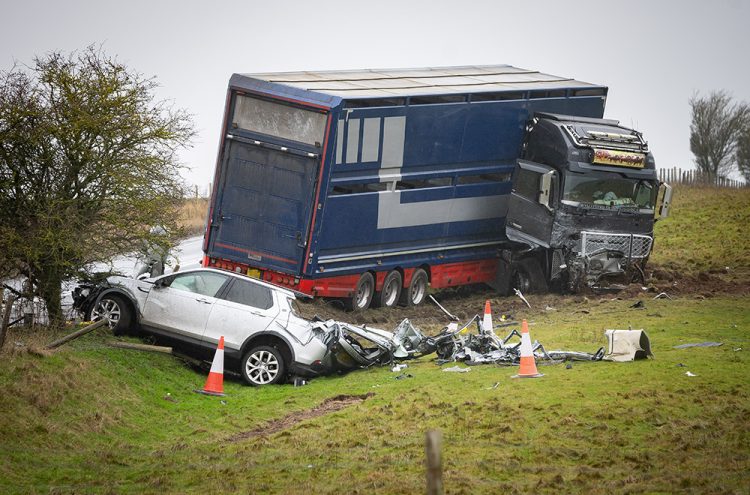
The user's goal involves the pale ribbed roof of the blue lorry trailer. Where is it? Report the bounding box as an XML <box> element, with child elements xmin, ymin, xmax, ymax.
<box><xmin>232</xmin><ymin>65</ymin><xmax>602</xmax><ymax>99</ymax></box>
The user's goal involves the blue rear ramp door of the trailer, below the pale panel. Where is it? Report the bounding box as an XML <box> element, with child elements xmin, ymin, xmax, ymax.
<box><xmin>209</xmin><ymin>137</ymin><xmax>320</xmax><ymax>274</ymax></box>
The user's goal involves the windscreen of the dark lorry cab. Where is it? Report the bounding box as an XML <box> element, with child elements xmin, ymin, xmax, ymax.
<box><xmin>562</xmin><ymin>173</ymin><xmax>658</xmax><ymax>213</ymax></box>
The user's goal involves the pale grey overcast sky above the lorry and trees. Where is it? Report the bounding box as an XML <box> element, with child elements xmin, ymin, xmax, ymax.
<box><xmin>0</xmin><ymin>0</ymin><xmax>750</xmax><ymax>188</ymax></box>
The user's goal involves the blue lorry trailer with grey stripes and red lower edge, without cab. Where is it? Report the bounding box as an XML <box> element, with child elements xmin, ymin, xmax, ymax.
<box><xmin>204</xmin><ymin>65</ymin><xmax>668</xmax><ymax>309</ymax></box>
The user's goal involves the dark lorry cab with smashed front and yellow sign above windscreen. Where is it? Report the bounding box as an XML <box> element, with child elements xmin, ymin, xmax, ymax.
<box><xmin>506</xmin><ymin>113</ymin><xmax>671</xmax><ymax>292</ymax></box>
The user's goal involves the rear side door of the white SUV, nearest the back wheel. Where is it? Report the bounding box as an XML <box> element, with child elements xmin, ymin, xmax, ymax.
<box><xmin>203</xmin><ymin>277</ymin><xmax>286</xmax><ymax>352</ymax></box>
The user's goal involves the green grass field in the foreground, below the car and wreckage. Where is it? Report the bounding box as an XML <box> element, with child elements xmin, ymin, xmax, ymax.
<box><xmin>0</xmin><ymin>297</ymin><xmax>750</xmax><ymax>494</ymax></box>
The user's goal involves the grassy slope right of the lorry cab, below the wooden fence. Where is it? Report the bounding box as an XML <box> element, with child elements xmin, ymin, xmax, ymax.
<box><xmin>651</xmin><ymin>186</ymin><xmax>750</xmax><ymax>280</ymax></box>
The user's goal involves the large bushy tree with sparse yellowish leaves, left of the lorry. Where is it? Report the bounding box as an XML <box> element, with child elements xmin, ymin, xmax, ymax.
<box><xmin>0</xmin><ymin>47</ymin><xmax>193</xmax><ymax>322</ymax></box>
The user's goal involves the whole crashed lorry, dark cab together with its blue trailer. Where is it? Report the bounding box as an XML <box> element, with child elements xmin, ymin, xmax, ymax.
<box><xmin>203</xmin><ymin>65</ymin><xmax>671</xmax><ymax>310</ymax></box>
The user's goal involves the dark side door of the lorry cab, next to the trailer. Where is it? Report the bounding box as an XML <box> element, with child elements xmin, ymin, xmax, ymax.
<box><xmin>505</xmin><ymin>160</ymin><xmax>558</xmax><ymax>248</ymax></box>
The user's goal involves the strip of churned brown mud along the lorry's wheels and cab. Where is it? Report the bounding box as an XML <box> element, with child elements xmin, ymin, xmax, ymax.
<box><xmin>300</xmin><ymin>266</ymin><xmax>750</xmax><ymax>333</ymax></box>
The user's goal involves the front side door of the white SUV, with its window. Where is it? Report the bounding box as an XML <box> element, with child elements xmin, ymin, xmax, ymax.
<box><xmin>141</xmin><ymin>271</ymin><xmax>229</xmax><ymax>343</ymax></box>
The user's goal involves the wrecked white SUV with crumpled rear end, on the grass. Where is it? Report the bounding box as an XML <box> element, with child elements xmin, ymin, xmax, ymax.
<box><xmin>73</xmin><ymin>268</ymin><xmax>435</xmax><ymax>385</ymax></box>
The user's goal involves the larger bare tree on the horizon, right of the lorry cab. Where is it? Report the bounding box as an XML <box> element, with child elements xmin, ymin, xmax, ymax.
<box><xmin>690</xmin><ymin>91</ymin><xmax>750</xmax><ymax>181</ymax></box>
